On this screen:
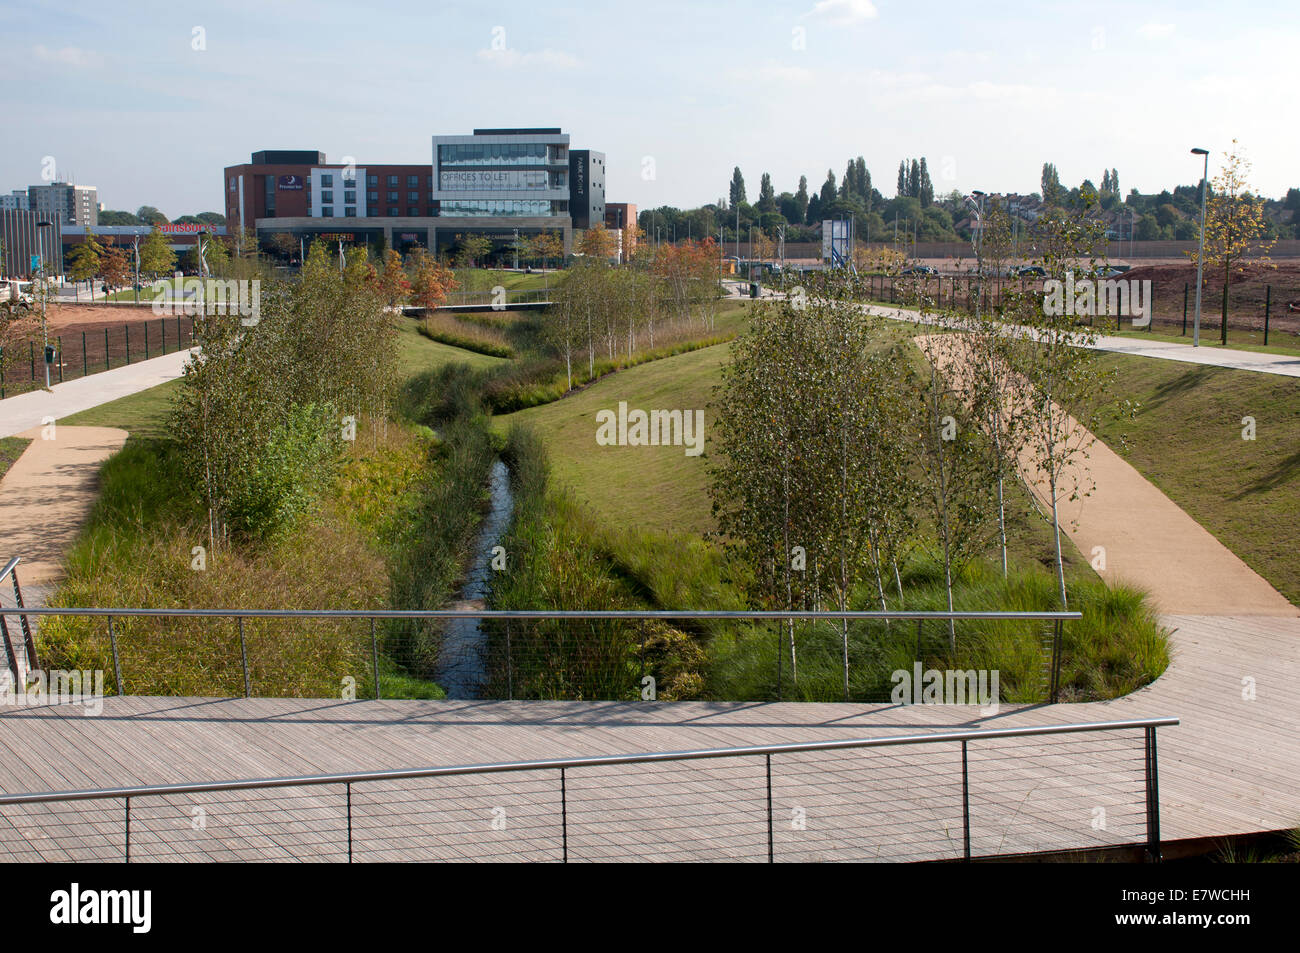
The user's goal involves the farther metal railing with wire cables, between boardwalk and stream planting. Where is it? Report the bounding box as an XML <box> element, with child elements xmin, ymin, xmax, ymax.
<box><xmin>0</xmin><ymin>607</ymin><xmax>1082</xmax><ymax>703</ymax></box>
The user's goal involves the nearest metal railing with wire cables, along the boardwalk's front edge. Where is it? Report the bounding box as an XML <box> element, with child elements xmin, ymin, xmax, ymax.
<box><xmin>0</xmin><ymin>718</ymin><xmax>1178</xmax><ymax>862</ymax></box>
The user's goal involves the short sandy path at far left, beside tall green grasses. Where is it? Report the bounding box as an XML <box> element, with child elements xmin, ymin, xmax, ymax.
<box><xmin>0</xmin><ymin>425</ymin><xmax>126</xmax><ymax>585</ymax></box>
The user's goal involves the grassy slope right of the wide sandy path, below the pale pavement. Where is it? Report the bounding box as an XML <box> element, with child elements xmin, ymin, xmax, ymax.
<box><xmin>1097</xmin><ymin>354</ymin><xmax>1300</xmax><ymax>603</ymax></box>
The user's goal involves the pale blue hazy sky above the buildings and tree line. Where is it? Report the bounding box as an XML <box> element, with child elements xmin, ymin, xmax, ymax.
<box><xmin>0</xmin><ymin>0</ymin><xmax>1300</xmax><ymax>218</ymax></box>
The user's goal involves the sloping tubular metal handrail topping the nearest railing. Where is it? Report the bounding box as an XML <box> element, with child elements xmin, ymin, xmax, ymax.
<box><xmin>0</xmin><ymin>716</ymin><xmax>1179</xmax><ymax>805</ymax></box>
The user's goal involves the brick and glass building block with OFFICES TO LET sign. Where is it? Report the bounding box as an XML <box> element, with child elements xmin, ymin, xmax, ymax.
<box><xmin>222</xmin><ymin>129</ymin><xmax>605</xmax><ymax>261</ymax></box>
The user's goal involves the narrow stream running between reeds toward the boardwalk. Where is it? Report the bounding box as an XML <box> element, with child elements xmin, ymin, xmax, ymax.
<box><xmin>433</xmin><ymin>460</ymin><xmax>515</xmax><ymax>698</ymax></box>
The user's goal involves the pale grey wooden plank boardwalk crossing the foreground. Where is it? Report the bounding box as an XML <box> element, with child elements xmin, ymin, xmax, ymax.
<box><xmin>0</xmin><ymin>616</ymin><xmax>1300</xmax><ymax>861</ymax></box>
